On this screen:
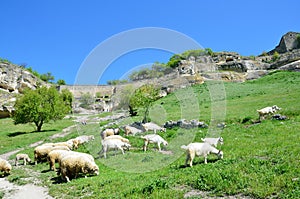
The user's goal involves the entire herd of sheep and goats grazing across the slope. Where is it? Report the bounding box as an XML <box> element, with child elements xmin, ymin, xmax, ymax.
<box><xmin>0</xmin><ymin>105</ymin><xmax>280</xmax><ymax>182</ymax></box>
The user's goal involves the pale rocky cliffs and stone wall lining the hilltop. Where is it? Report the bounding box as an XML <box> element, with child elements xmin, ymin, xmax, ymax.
<box><xmin>0</xmin><ymin>32</ymin><xmax>300</xmax><ymax>118</ymax></box>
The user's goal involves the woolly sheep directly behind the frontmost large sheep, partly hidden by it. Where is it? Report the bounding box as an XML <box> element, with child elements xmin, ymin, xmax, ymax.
<box><xmin>47</xmin><ymin>150</ymin><xmax>95</xmax><ymax>171</ymax></box>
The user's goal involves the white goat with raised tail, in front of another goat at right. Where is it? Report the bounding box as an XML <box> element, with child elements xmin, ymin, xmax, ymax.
<box><xmin>181</xmin><ymin>142</ymin><xmax>223</xmax><ymax>167</ymax></box>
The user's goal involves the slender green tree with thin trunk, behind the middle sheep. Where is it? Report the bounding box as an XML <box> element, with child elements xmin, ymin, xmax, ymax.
<box><xmin>129</xmin><ymin>84</ymin><xmax>160</xmax><ymax>123</ymax></box>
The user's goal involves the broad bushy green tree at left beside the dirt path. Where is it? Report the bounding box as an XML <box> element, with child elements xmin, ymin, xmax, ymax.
<box><xmin>13</xmin><ymin>87</ymin><xmax>70</xmax><ymax>132</ymax></box>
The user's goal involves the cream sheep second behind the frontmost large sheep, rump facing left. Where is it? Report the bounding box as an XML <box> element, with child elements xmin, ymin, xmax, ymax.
<box><xmin>34</xmin><ymin>145</ymin><xmax>70</xmax><ymax>165</ymax></box>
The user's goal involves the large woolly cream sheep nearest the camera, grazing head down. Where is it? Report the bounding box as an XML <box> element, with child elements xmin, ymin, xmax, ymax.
<box><xmin>59</xmin><ymin>154</ymin><xmax>99</xmax><ymax>182</ymax></box>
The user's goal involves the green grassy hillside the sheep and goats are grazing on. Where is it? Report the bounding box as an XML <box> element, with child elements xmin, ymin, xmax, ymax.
<box><xmin>0</xmin><ymin>72</ymin><xmax>300</xmax><ymax>198</ymax></box>
